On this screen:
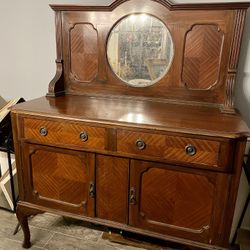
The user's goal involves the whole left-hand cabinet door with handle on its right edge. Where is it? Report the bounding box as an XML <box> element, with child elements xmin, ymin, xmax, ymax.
<box><xmin>23</xmin><ymin>144</ymin><xmax>94</xmax><ymax>216</ymax></box>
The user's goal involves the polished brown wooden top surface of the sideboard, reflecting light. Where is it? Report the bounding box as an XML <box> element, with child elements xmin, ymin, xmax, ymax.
<box><xmin>12</xmin><ymin>95</ymin><xmax>250</xmax><ymax>138</ymax></box>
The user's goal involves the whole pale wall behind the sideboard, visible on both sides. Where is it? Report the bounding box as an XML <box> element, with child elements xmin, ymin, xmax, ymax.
<box><xmin>0</xmin><ymin>0</ymin><xmax>250</xmax><ymax>232</ymax></box>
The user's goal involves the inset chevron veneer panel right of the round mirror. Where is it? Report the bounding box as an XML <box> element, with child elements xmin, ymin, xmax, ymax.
<box><xmin>182</xmin><ymin>24</ymin><xmax>224</xmax><ymax>90</ymax></box>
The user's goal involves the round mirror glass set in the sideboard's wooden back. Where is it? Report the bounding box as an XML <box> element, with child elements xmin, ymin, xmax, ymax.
<box><xmin>107</xmin><ymin>14</ymin><xmax>174</xmax><ymax>87</ymax></box>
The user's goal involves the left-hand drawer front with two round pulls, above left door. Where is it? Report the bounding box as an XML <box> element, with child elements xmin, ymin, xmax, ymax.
<box><xmin>24</xmin><ymin>118</ymin><xmax>106</xmax><ymax>149</ymax></box>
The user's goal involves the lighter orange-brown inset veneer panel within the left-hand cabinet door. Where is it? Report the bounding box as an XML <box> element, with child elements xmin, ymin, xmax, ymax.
<box><xmin>31</xmin><ymin>150</ymin><xmax>89</xmax><ymax>206</ymax></box>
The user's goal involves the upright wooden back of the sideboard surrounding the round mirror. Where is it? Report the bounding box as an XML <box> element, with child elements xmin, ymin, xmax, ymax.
<box><xmin>48</xmin><ymin>0</ymin><xmax>249</xmax><ymax>111</ymax></box>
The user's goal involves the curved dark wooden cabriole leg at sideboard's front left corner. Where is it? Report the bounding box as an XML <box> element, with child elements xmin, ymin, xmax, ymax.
<box><xmin>16</xmin><ymin>204</ymin><xmax>42</xmax><ymax>248</ymax></box>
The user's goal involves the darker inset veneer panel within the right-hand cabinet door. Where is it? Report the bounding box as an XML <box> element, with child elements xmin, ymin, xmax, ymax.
<box><xmin>139</xmin><ymin>168</ymin><xmax>214</xmax><ymax>232</ymax></box>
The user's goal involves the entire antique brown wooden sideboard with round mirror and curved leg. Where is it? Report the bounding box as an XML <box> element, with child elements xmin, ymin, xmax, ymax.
<box><xmin>12</xmin><ymin>0</ymin><xmax>250</xmax><ymax>249</ymax></box>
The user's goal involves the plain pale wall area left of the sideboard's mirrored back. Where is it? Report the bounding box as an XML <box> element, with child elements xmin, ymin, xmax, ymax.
<box><xmin>0</xmin><ymin>0</ymin><xmax>110</xmax><ymax>100</ymax></box>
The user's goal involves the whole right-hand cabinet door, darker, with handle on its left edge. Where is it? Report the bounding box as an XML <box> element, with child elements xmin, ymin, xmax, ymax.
<box><xmin>129</xmin><ymin>161</ymin><xmax>228</xmax><ymax>243</ymax></box>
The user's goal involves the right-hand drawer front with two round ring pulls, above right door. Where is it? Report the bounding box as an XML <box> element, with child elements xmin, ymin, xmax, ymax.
<box><xmin>117</xmin><ymin>130</ymin><xmax>232</xmax><ymax>168</ymax></box>
